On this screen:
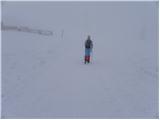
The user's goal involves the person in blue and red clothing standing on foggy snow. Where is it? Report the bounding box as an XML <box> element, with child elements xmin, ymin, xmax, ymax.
<box><xmin>84</xmin><ymin>36</ymin><xmax>93</xmax><ymax>64</ymax></box>
